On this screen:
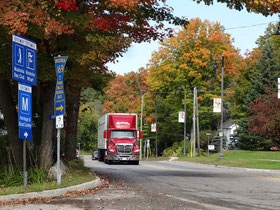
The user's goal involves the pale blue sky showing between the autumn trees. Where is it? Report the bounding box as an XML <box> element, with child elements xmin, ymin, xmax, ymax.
<box><xmin>108</xmin><ymin>0</ymin><xmax>279</xmax><ymax>74</ymax></box>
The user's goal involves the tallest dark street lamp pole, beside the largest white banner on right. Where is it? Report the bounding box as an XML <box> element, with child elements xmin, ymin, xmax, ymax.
<box><xmin>213</xmin><ymin>56</ymin><xmax>225</xmax><ymax>159</ymax></box>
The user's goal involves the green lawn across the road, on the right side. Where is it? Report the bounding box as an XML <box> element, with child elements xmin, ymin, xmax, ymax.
<box><xmin>179</xmin><ymin>150</ymin><xmax>280</xmax><ymax>170</ymax></box>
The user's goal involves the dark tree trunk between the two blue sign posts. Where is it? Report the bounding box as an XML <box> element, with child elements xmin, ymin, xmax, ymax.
<box><xmin>39</xmin><ymin>82</ymin><xmax>55</xmax><ymax>169</ymax></box>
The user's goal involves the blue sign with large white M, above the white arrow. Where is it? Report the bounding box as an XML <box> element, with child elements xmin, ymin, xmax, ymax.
<box><xmin>18</xmin><ymin>83</ymin><xmax>32</xmax><ymax>130</ymax></box>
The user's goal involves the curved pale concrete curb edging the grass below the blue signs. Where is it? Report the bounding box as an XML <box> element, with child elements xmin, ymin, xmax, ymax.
<box><xmin>0</xmin><ymin>177</ymin><xmax>102</xmax><ymax>201</ymax></box>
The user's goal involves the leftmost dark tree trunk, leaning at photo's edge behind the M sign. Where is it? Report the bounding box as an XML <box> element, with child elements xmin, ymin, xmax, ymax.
<box><xmin>0</xmin><ymin>79</ymin><xmax>23</xmax><ymax>167</ymax></box>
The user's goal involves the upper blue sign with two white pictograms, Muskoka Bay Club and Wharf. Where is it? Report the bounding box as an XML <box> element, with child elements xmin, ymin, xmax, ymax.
<box><xmin>12</xmin><ymin>34</ymin><xmax>37</xmax><ymax>85</ymax></box>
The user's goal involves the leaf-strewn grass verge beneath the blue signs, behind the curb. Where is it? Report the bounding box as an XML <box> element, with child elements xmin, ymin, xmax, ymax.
<box><xmin>0</xmin><ymin>160</ymin><xmax>96</xmax><ymax>195</ymax></box>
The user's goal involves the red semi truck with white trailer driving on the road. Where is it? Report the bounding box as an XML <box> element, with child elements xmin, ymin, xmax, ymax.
<box><xmin>98</xmin><ymin>113</ymin><xmax>142</xmax><ymax>165</ymax></box>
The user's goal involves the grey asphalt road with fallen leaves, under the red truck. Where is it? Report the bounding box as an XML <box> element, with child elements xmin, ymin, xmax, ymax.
<box><xmin>2</xmin><ymin>156</ymin><xmax>280</xmax><ymax>210</ymax></box>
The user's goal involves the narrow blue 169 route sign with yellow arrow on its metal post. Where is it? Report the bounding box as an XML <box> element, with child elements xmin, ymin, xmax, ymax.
<box><xmin>54</xmin><ymin>56</ymin><xmax>67</xmax><ymax>185</ymax></box>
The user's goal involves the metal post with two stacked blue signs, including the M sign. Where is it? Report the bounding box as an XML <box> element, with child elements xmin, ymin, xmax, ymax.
<box><xmin>12</xmin><ymin>34</ymin><xmax>37</xmax><ymax>188</ymax></box>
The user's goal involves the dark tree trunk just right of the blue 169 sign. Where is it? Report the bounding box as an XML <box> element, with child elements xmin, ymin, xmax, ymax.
<box><xmin>65</xmin><ymin>87</ymin><xmax>81</xmax><ymax>160</ymax></box>
